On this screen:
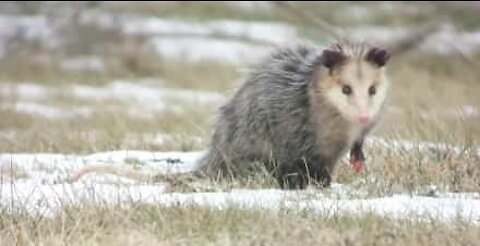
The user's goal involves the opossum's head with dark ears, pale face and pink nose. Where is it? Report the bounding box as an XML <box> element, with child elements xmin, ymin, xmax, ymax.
<box><xmin>318</xmin><ymin>44</ymin><xmax>389</xmax><ymax>124</ymax></box>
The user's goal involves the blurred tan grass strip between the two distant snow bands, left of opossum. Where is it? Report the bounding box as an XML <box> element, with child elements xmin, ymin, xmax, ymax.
<box><xmin>0</xmin><ymin>48</ymin><xmax>240</xmax><ymax>92</ymax></box>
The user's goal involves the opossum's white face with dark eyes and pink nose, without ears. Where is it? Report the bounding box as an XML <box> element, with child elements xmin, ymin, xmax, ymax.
<box><xmin>320</xmin><ymin>47</ymin><xmax>388</xmax><ymax>124</ymax></box>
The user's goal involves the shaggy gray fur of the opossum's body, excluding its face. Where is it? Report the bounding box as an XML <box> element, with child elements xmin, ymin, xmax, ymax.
<box><xmin>197</xmin><ymin>43</ymin><xmax>378</xmax><ymax>188</ymax></box>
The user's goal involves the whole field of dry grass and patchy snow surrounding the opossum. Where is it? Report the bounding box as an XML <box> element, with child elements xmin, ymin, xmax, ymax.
<box><xmin>0</xmin><ymin>2</ymin><xmax>480</xmax><ymax>245</ymax></box>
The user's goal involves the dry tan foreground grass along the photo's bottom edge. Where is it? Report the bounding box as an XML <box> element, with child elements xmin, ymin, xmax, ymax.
<box><xmin>0</xmin><ymin>204</ymin><xmax>480</xmax><ymax>245</ymax></box>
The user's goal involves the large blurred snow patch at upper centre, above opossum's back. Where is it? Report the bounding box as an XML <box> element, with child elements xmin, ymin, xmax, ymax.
<box><xmin>131</xmin><ymin>18</ymin><xmax>299</xmax><ymax>64</ymax></box>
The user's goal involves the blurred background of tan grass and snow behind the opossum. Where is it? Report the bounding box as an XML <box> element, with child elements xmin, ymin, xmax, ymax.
<box><xmin>0</xmin><ymin>1</ymin><xmax>480</xmax><ymax>153</ymax></box>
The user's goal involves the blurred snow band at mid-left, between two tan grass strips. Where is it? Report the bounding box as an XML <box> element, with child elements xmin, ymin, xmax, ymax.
<box><xmin>0</xmin><ymin>80</ymin><xmax>225</xmax><ymax>119</ymax></box>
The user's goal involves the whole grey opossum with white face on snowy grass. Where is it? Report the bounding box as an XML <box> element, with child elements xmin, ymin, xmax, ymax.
<box><xmin>73</xmin><ymin>41</ymin><xmax>390</xmax><ymax>189</ymax></box>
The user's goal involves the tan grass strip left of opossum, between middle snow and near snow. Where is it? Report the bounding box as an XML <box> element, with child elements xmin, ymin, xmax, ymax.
<box><xmin>0</xmin><ymin>105</ymin><xmax>213</xmax><ymax>153</ymax></box>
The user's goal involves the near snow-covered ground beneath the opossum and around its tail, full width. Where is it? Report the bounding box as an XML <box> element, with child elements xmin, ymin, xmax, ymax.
<box><xmin>0</xmin><ymin>139</ymin><xmax>480</xmax><ymax>224</ymax></box>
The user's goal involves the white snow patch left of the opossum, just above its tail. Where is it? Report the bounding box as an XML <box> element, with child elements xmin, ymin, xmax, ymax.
<box><xmin>0</xmin><ymin>150</ymin><xmax>203</xmax><ymax>184</ymax></box>
